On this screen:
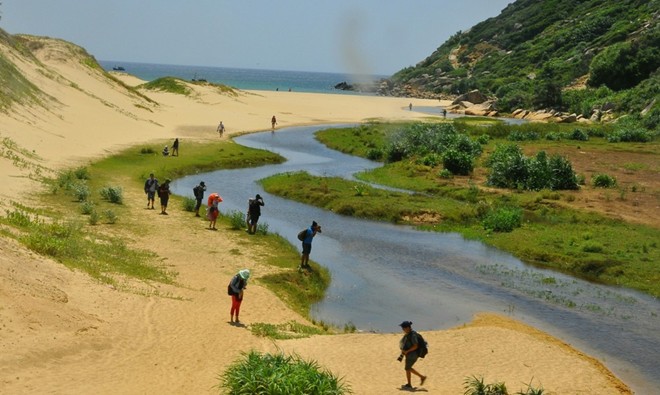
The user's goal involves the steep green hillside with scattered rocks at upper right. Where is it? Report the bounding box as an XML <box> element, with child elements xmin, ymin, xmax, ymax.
<box><xmin>392</xmin><ymin>0</ymin><xmax>660</xmax><ymax>129</ymax></box>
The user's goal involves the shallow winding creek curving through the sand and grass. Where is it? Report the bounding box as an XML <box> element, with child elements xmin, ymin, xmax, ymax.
<box><xmin>172</xmin><ymin>126</ymin><xmax>660</xmax><ymax>394</ymax></box>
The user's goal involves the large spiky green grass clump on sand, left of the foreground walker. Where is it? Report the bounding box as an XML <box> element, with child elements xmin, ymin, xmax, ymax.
<box><xmin>217</xmin><ymin>351</ymin><xmax>352</xmax><ymax>395</ymax></box>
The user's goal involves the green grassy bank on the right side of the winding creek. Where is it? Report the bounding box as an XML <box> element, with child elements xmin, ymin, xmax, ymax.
<box><xmin>262</xmin><ymin>125</ymin><xmax>660</xmax><ymax>296</ymax></box>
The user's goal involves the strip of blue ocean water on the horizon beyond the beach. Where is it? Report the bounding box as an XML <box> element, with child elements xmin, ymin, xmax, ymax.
<box><xmin>99</xmin><ymin>60</ymin><xmax>388</xmax><ymax>94</ymax></box>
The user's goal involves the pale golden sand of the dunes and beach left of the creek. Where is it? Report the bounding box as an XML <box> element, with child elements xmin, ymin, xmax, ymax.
<box><xmin>0</xmin><ymin>41</ymin><xmax>629</xmax><ymax>394</ymax></box>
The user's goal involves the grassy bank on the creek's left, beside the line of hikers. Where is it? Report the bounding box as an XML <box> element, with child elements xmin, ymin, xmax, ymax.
<box><xmin>0</xmin><ymin>141</ymin><xmax>330</xmax><ymax>316</ymax></box>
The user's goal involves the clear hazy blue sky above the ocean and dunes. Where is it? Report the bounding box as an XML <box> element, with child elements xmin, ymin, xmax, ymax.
<box><xmin>0</xmin><ymin>0</ymin><xmax>513</xmax><ymax>75</ymax></box>
